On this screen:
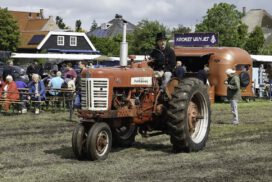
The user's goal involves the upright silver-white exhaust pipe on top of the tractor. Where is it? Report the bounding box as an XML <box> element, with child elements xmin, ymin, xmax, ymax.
<box><xmin>120</xmin><ymin>21</ymin><xmax>128</xmax><ymax>67</ymax></box>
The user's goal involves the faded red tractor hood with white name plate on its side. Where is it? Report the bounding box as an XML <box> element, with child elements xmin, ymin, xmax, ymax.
<box><xmin>81</xmin><ymin>67</ymin><xmax>154</xmax><ymax>87</ymax></box>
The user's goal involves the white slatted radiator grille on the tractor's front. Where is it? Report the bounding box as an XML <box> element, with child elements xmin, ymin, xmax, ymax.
<box><xmin>81</xmin><ymin>78</ymin><xmax>109</xmax><ymax>111</ymax></box>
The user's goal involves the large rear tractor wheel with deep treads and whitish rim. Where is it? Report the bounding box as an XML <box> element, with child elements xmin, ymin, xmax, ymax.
<box><xmin>167</xmin><ymin>78</ymin><xmax>211</xmax><ymax>152</ymax></box>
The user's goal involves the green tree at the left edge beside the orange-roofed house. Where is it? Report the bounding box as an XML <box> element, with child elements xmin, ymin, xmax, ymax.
<box><xmin>0</xmin><ymin>8</ymin><xmax>20</xmax><ymax>51</ymax></box>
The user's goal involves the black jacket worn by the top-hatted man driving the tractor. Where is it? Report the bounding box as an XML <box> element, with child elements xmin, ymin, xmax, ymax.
<box><xmin>150</xmin><ymin>47</ymin><xmax>176</xmax><ymax>72</ymax></box>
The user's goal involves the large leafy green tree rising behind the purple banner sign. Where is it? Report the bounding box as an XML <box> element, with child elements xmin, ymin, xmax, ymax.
<box><xmin>196</xmin><ymin>3</ymin><xmax>247</xmax><ymax>47</ymax></box>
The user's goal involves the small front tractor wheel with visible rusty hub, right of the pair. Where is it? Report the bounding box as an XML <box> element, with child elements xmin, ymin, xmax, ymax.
<box><xmin>87</xmin><ymin>122</ymin><xmax>112</xmax><ymax>161</ymax></box>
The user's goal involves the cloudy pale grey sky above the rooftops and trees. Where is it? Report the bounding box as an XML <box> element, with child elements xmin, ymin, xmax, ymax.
<box><xmin>0</xmin><ymin>0</ymin><xmax>272</xmax><ymax>31</ymax></box>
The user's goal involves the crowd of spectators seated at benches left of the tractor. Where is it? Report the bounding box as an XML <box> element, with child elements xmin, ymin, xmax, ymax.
<box><xmin>0</xmin><ymin>60</ymin><xmax>87</xmax><ymax>114</ymax></box>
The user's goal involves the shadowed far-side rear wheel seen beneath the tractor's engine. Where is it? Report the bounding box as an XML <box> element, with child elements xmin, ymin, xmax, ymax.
<box><xmin>112</xmin><ymin>123</ymin><xmax>137</xmax><ymax>147</ymax></box>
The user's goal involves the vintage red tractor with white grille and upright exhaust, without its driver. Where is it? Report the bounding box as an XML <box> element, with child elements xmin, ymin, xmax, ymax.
<box><xmin>72</xmin><ymin>23</ymin><xmax>211</xmax><ymax>160</ymax></box>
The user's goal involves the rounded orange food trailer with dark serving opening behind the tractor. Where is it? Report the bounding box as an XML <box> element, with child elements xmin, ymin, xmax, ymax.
<box><xmin>174</xmin><ymin>47</ymin><xmax>254</xmax><ymax>100</ymax></box>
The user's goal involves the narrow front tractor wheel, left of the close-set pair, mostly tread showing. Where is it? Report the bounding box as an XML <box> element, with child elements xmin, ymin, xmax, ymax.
<box><xmin>72</xmin><ymin>124</ymin><xmax>87</xmax><ymax>160</ymax></box>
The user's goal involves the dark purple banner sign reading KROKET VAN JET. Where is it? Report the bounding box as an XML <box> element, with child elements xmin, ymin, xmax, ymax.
<box><xmin>174</xmin><ymin>33</ymin><xmax>218</xmax><ymax>47</ymax></box>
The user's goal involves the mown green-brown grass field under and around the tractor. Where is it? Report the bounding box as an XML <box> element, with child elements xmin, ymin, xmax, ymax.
<box><xmin>0</xmin><ymin>100</ymin><xmax>272</xmax><ymax>182</ymax></box>
